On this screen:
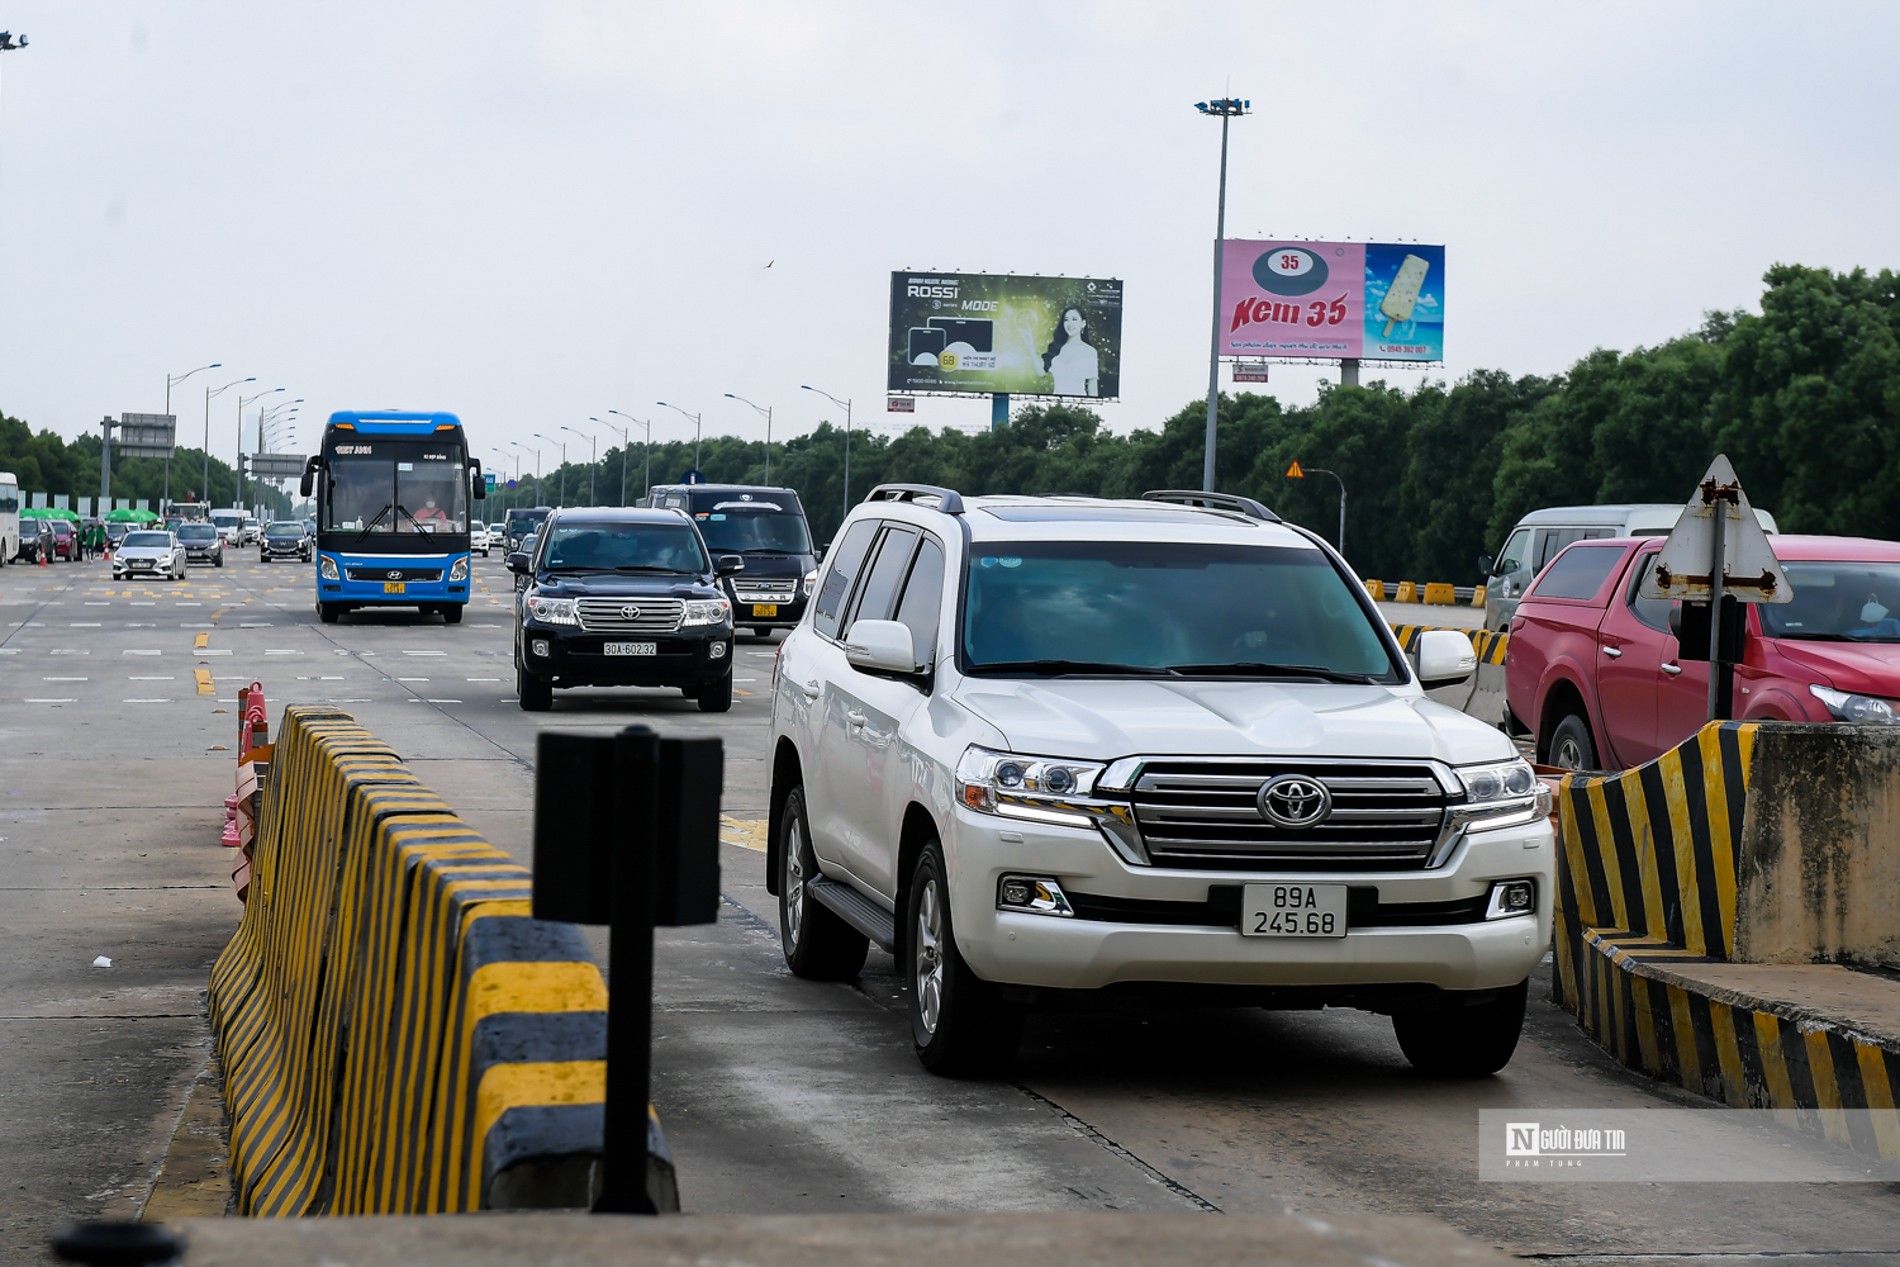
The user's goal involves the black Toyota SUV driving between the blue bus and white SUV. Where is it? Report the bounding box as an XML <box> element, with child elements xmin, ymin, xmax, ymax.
<box><xmin>507</xmin><ymin>509</ymin><xmax>745</xmax><ymax>712</ymax></box>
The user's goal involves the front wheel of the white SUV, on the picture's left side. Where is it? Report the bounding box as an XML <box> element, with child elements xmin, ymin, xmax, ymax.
<box><xmin>899</xmin><ymin>840</ymin><xmax>1022</xmax><ymax>1077</ymax></box>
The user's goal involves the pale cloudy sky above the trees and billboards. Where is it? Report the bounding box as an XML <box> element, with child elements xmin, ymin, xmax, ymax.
<box><xmin>0</xmin><ymin>0</ymin><xmax>1900</xmax><ymax>474</ymax></box>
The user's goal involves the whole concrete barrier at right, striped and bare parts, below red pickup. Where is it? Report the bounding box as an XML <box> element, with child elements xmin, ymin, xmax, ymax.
<box><xmin>1552</xmin><ymin>722</ymin><xmax>1900</xmax><ymax>1161</ymax></box>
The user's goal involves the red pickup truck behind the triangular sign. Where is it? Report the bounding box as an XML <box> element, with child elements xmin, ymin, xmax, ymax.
<box><xmin>1505</xmin><ymin>536</ymin><xmax>1900</xmax><ymax>769</ymax></box>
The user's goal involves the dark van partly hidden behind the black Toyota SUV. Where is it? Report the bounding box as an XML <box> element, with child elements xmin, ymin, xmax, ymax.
<box><xmin>650</xmin><ymin>484</ymin><xmax>819</xmax><ymax>634</ymax></box>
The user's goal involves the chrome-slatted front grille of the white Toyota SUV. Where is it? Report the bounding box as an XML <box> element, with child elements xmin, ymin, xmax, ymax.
<box><xmin>1131</xmin><ymin>762</ymin><xmax>1452</xmax><ymax>870</ymax></box>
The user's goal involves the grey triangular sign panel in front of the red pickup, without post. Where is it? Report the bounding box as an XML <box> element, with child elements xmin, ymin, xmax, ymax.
<box><xmin>1642</xmin><ymin>454</ymin><xmax>1794</xmax><ymax>602</ymax></box>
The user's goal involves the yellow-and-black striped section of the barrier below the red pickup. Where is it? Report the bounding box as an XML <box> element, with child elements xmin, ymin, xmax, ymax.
<box><xmin>1552</xmin><ymin>722</ymin><xmax>1900</xmax><ymax>1161</ymax></box>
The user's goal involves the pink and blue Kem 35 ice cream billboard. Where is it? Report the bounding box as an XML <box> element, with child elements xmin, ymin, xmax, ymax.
<box><xmin>1220</xmin><ymin>241</ymin><xmax>1444</xmax><ymax>361</ymax></box>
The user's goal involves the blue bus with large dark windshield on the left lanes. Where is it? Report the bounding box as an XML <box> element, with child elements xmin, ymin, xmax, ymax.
<box><xmin>302</xmin><ymin>412</ymin><xmax>486</xmax><ymax>625</ymax></box>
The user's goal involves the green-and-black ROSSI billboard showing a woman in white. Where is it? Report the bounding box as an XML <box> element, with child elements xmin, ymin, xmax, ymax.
<box><xmin>887</xmin><ymin>274</ymin><xmax>1121</xmax><ymax>397</ymax></box>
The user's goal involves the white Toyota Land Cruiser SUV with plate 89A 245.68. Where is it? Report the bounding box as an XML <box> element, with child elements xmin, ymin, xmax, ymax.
<box><xmin>768</xmin><ymin>484</ymin><xmax>1554</xmax><ymax>1075</ymax></box>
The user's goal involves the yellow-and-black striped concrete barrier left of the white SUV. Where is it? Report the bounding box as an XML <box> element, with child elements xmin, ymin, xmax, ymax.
<box><xmin>211</xmin><ymin>707</ymin><xmax>638</xmax><ymax>1216</ymax></box>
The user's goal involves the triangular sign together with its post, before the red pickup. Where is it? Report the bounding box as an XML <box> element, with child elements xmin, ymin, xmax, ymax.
<box><xmin>1640</xmin><ymin>454</ymin><xmax>1794</xmax><ymax>722</ymax></box>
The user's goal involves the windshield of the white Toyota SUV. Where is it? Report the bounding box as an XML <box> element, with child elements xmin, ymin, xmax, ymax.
<box><xmin>963</xmin><ymin>541</ymin><xmax>1404</xmax><ymax>682</ymax></box>
